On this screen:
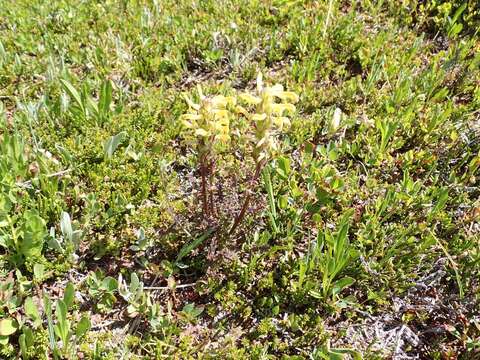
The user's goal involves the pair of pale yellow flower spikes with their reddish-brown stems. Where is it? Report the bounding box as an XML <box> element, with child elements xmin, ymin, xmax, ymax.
<box><xmin>180</xmin><ymin>74</ymin><xmax>298</xmax><ymax>225</ymax></box>
